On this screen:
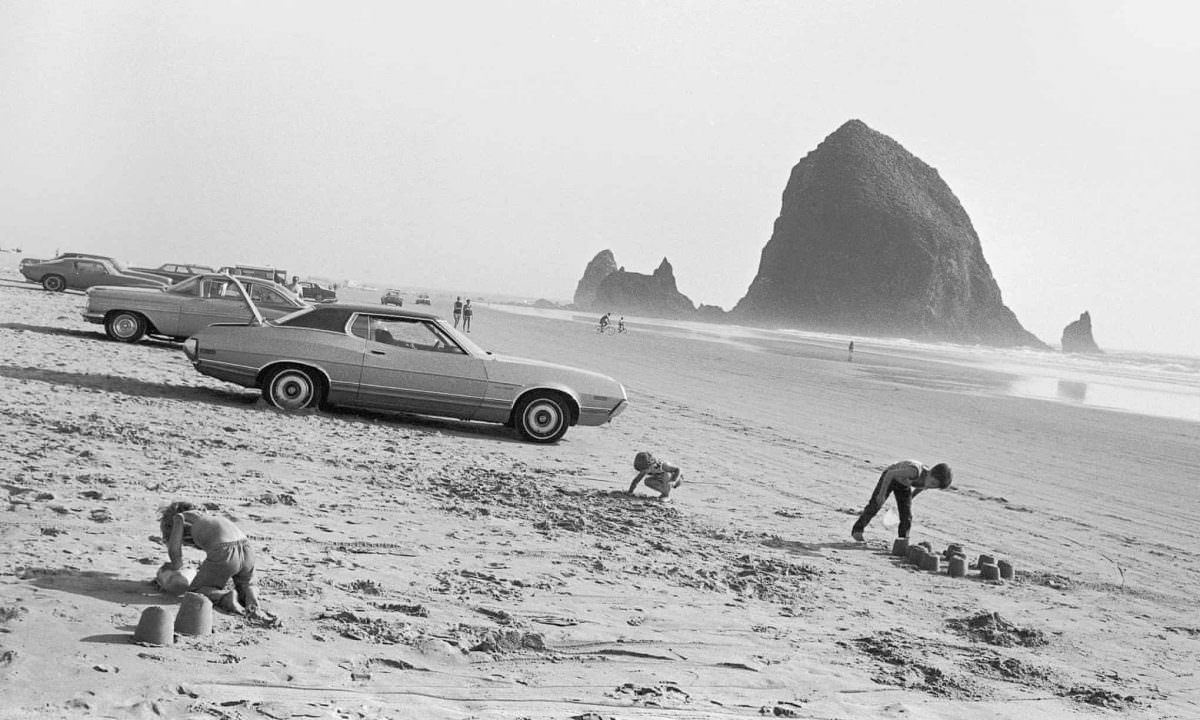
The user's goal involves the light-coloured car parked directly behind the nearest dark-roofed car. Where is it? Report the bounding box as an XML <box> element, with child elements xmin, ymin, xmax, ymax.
<box><xmin>83</xmin><ymin>272</ymin><xmax>307</xmax><ymax>342</ymax></box>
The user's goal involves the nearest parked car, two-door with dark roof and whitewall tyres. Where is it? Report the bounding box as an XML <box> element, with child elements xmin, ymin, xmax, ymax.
<box><xmin>184</xmin><ymin>294</ymin><xmax>628</xmax><ymax>443</ymax></box>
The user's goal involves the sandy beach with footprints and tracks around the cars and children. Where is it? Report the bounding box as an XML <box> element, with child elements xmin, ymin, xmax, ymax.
<box><xmin>0</xmin><ymin>274</ymin><xmax>1200</xmax><ymax>720</ymax></box>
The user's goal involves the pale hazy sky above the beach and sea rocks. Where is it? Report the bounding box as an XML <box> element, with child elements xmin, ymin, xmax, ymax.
<box><xmin>0</xmin><ymin>0</ymin><xmax>1200</xmax><ymax>355</ymax></box>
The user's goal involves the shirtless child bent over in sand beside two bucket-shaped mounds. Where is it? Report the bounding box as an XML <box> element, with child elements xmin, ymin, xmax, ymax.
<box><xmin>158</xmin><ymin>500</ymin><xmax>275</xmax><ymax>620</ymax></box>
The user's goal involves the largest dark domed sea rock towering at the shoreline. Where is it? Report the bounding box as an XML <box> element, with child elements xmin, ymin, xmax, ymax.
<box><xmin>733</xmin><ymin>120</ymin><xmax>1046</xmax><ymax>348</ymax></box>
